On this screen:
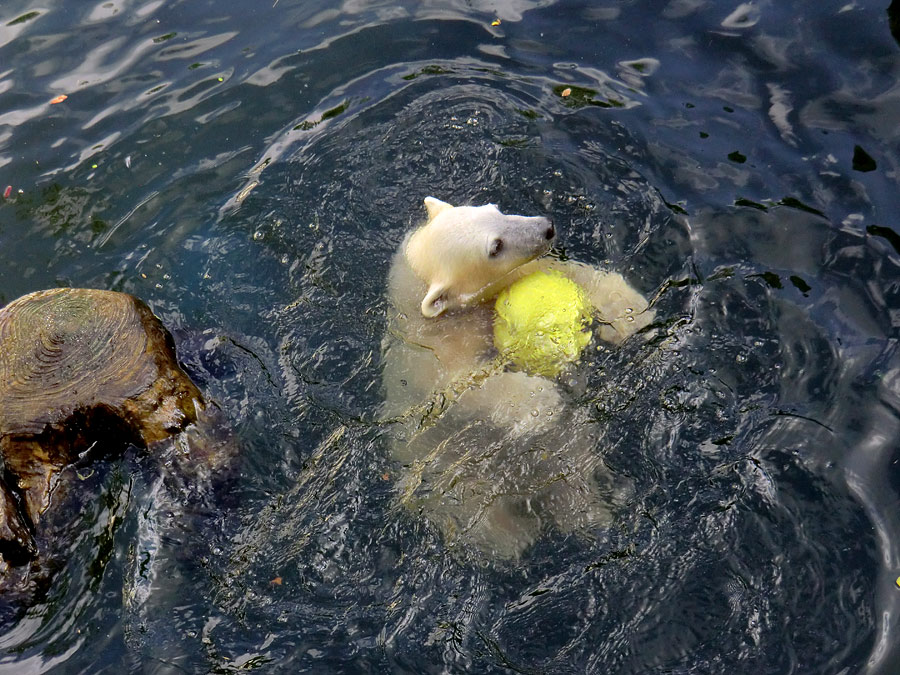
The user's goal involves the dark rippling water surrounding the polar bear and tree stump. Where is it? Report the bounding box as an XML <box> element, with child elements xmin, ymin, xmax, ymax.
<box><xmin>0</xmin><ymin>0</ymin><xmax>900</xmax><ymax>674</ymax></box>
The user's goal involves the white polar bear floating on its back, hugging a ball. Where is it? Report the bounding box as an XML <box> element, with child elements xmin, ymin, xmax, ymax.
<box><xmin>383</xmin><ymin>197</ymin><xmax>653</xmax><ymax>558</ymax></box>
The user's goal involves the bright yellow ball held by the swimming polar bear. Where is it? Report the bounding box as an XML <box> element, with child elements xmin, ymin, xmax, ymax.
<box><xmin>494</xmin><ymin>271</ymin><xmax>591</xmax><ymax>377</ymax></box>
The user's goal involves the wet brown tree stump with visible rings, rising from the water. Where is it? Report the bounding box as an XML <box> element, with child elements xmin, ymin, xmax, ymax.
<box><xmin>0</xmin><ymin>288</ymin><xmax>204</xmax><ymax>565</ymax></box>
